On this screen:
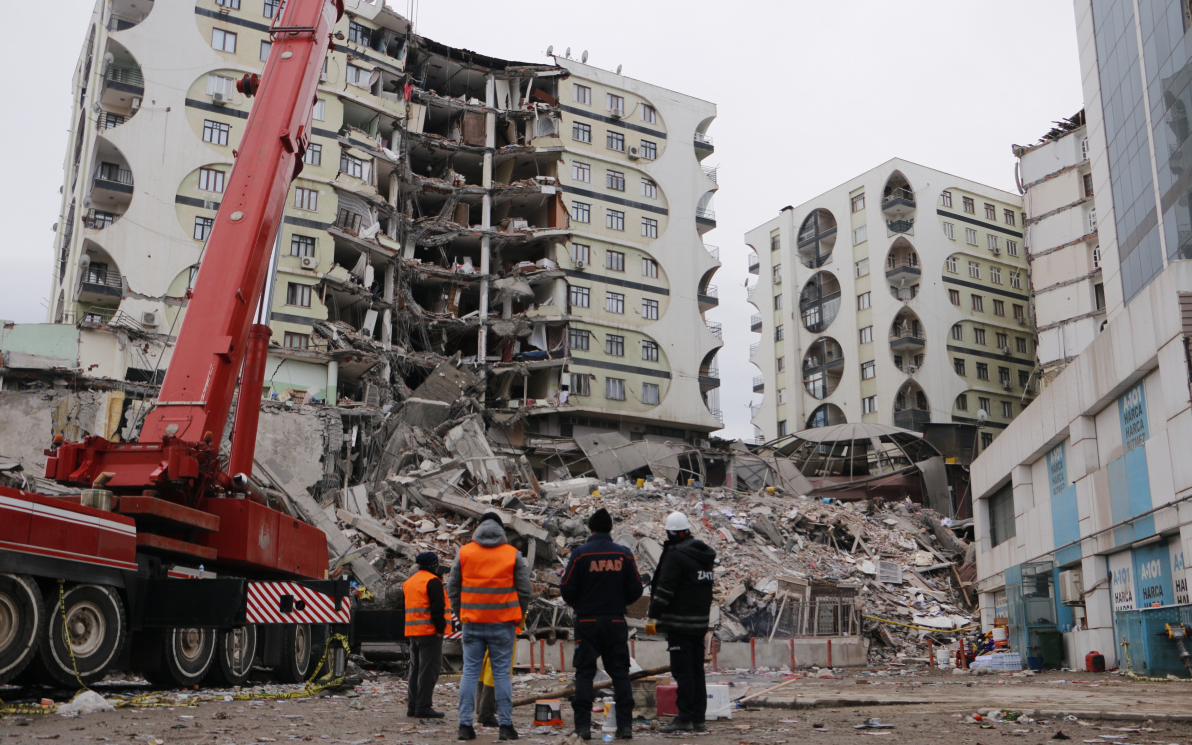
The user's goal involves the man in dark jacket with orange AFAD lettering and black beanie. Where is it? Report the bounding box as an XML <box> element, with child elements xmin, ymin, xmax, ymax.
<box><xmin>559</xmin><ymin>508</ymin><xmax>641</xmax><ymax>740</ymax></box>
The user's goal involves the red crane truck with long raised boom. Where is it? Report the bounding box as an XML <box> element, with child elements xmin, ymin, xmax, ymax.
<box><xmin>0</xmin><ymin>0</ymin><xmax>402</xmax><ymax>687</ymax></box>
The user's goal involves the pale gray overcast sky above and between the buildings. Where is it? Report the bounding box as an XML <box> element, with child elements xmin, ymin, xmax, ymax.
<box><xmin>0</xmin><ymin>0</ymin><xmax>1082</xmax><ymax>437</ymax></box>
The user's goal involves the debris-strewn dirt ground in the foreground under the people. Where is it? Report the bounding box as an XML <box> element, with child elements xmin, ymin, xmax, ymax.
<box><xmin>0</xmin><ymin>671</ymin><xmax>1192</xmax><ymax>745</ymax></box>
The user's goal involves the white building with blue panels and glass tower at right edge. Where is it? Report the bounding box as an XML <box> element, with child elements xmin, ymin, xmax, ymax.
<box><xmin>971</xmin><ymin>0</ymin><xmax>1192</xmax><ymax>676</ymax></box>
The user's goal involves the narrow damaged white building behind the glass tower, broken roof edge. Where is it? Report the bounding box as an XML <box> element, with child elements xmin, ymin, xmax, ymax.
<box><xmin>1013</xmin><ymin>111</ymin><xmax>1105</xmax><ymax>385</ymax></box>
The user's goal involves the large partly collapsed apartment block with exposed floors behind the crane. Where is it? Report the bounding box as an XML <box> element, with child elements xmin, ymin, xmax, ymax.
<box><xmin>49</xmin><ymin>0</ymin><xmax>721</xmax><ymax>452</ymax></box>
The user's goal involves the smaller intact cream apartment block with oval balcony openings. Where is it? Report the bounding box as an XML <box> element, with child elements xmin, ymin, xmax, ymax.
<box><xmin>745</xmin><ymin>159</ymin><xmax>1035</xmax><ymax>445</ymax></box>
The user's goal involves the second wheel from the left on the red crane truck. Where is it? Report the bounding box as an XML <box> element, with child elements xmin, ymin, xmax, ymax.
<box><xmin>39</xmin><ymin>584</ymin><xmax>129</xmax><ymax>688</ymax></box>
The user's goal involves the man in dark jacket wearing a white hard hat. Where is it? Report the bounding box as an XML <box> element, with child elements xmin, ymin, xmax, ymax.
<box><xmin>646</xmin><ymin>513</ymin><xmax>716</xmax><ymax>733</ymax></box>
